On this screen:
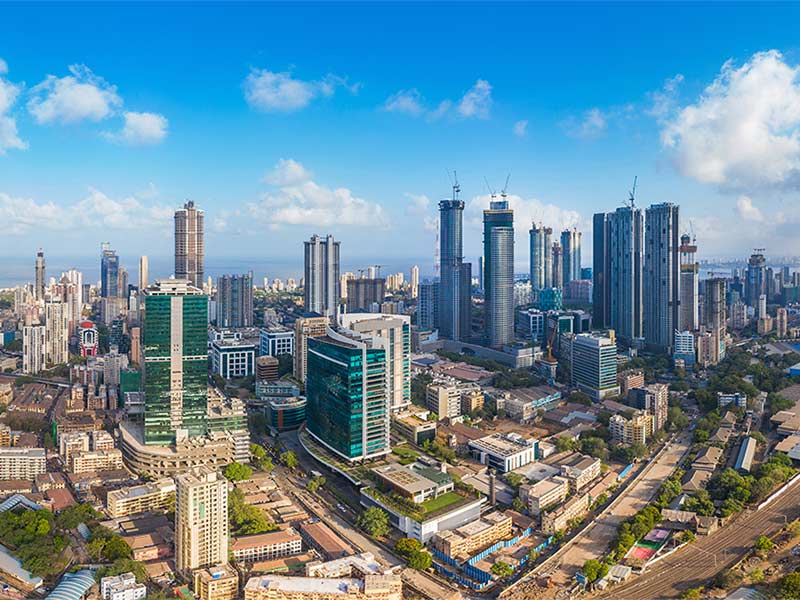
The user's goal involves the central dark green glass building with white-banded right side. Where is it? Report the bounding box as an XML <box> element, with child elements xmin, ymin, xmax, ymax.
<box><xmin>306</xmin><ymin>329</ymin><xmax>391</xmax><ymax>461</ymax></box>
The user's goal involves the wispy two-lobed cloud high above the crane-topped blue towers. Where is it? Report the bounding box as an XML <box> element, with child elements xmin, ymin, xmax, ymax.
<box><xmin>383</xmin><ymin>79</ymin><xmax>492</xmax><ymax>121</ymax></box>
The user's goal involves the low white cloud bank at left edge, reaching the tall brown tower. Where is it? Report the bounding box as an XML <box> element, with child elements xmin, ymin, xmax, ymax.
<box><xmin>0</xmin><ymin>188</ymin><xmax>173</xmax><ymax>234</ymax></box>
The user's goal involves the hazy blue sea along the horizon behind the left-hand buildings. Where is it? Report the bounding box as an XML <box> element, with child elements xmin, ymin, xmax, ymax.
<box><xmin>0</xmin><ymin>254</ymin><xmax>433</xmax><ymax>288</ymax></box>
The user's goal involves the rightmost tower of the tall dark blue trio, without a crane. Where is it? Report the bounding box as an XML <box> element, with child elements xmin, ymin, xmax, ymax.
<box><xmin>644</xmin><ymin>202</ymin><xmax>680</xmax><ymax>352</ymax></box>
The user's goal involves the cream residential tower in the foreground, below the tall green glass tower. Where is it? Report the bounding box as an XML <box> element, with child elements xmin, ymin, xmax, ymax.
<box><xmin>175</xmin><ymin>469</ymin><xmax>228</xmax><ymax>573</ymax></box>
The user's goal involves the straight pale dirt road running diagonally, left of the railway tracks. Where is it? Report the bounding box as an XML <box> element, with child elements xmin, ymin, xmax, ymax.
<box><xmin>502</xmin><ymin>431</ymin><xmax>692</xmax><ymax>600</ymax></box>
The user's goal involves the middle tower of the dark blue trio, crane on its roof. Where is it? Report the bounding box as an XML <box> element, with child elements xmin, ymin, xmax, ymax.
<box><xmin>607</xmin><ymin>206</ymin><xmax>644</xmax><ymax>341</ymax></box>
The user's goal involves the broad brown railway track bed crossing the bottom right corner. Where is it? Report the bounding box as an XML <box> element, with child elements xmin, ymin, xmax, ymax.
<box><xmin>599</xmin><ymin>482</ymin><xmax>800</xmax><ymax>600</ymax></box>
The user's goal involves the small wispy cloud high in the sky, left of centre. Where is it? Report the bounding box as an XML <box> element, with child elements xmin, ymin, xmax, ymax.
<box><xmin>242</xmin><ymin>69</ymin><xmax>360</xmax><ymax>112</ymax></box>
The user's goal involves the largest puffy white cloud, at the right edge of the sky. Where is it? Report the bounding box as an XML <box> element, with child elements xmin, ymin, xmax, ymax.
<box><xmin>661</xmin><ymin>50</ymin><xmax>800</xmax><ymax>189</ymax></box>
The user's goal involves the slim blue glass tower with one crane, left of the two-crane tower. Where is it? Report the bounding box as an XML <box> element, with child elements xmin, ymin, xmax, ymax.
<box><xmin>439</xmin><ymin>192</ymin><xmax>472</xmax><ymax>340</ymax></box>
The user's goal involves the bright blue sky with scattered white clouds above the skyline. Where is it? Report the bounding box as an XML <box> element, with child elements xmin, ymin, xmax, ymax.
<box><xmin>0</xmin><ymin>3</ymin><xmax>800</xmax><ymax>278</ymax></box>
